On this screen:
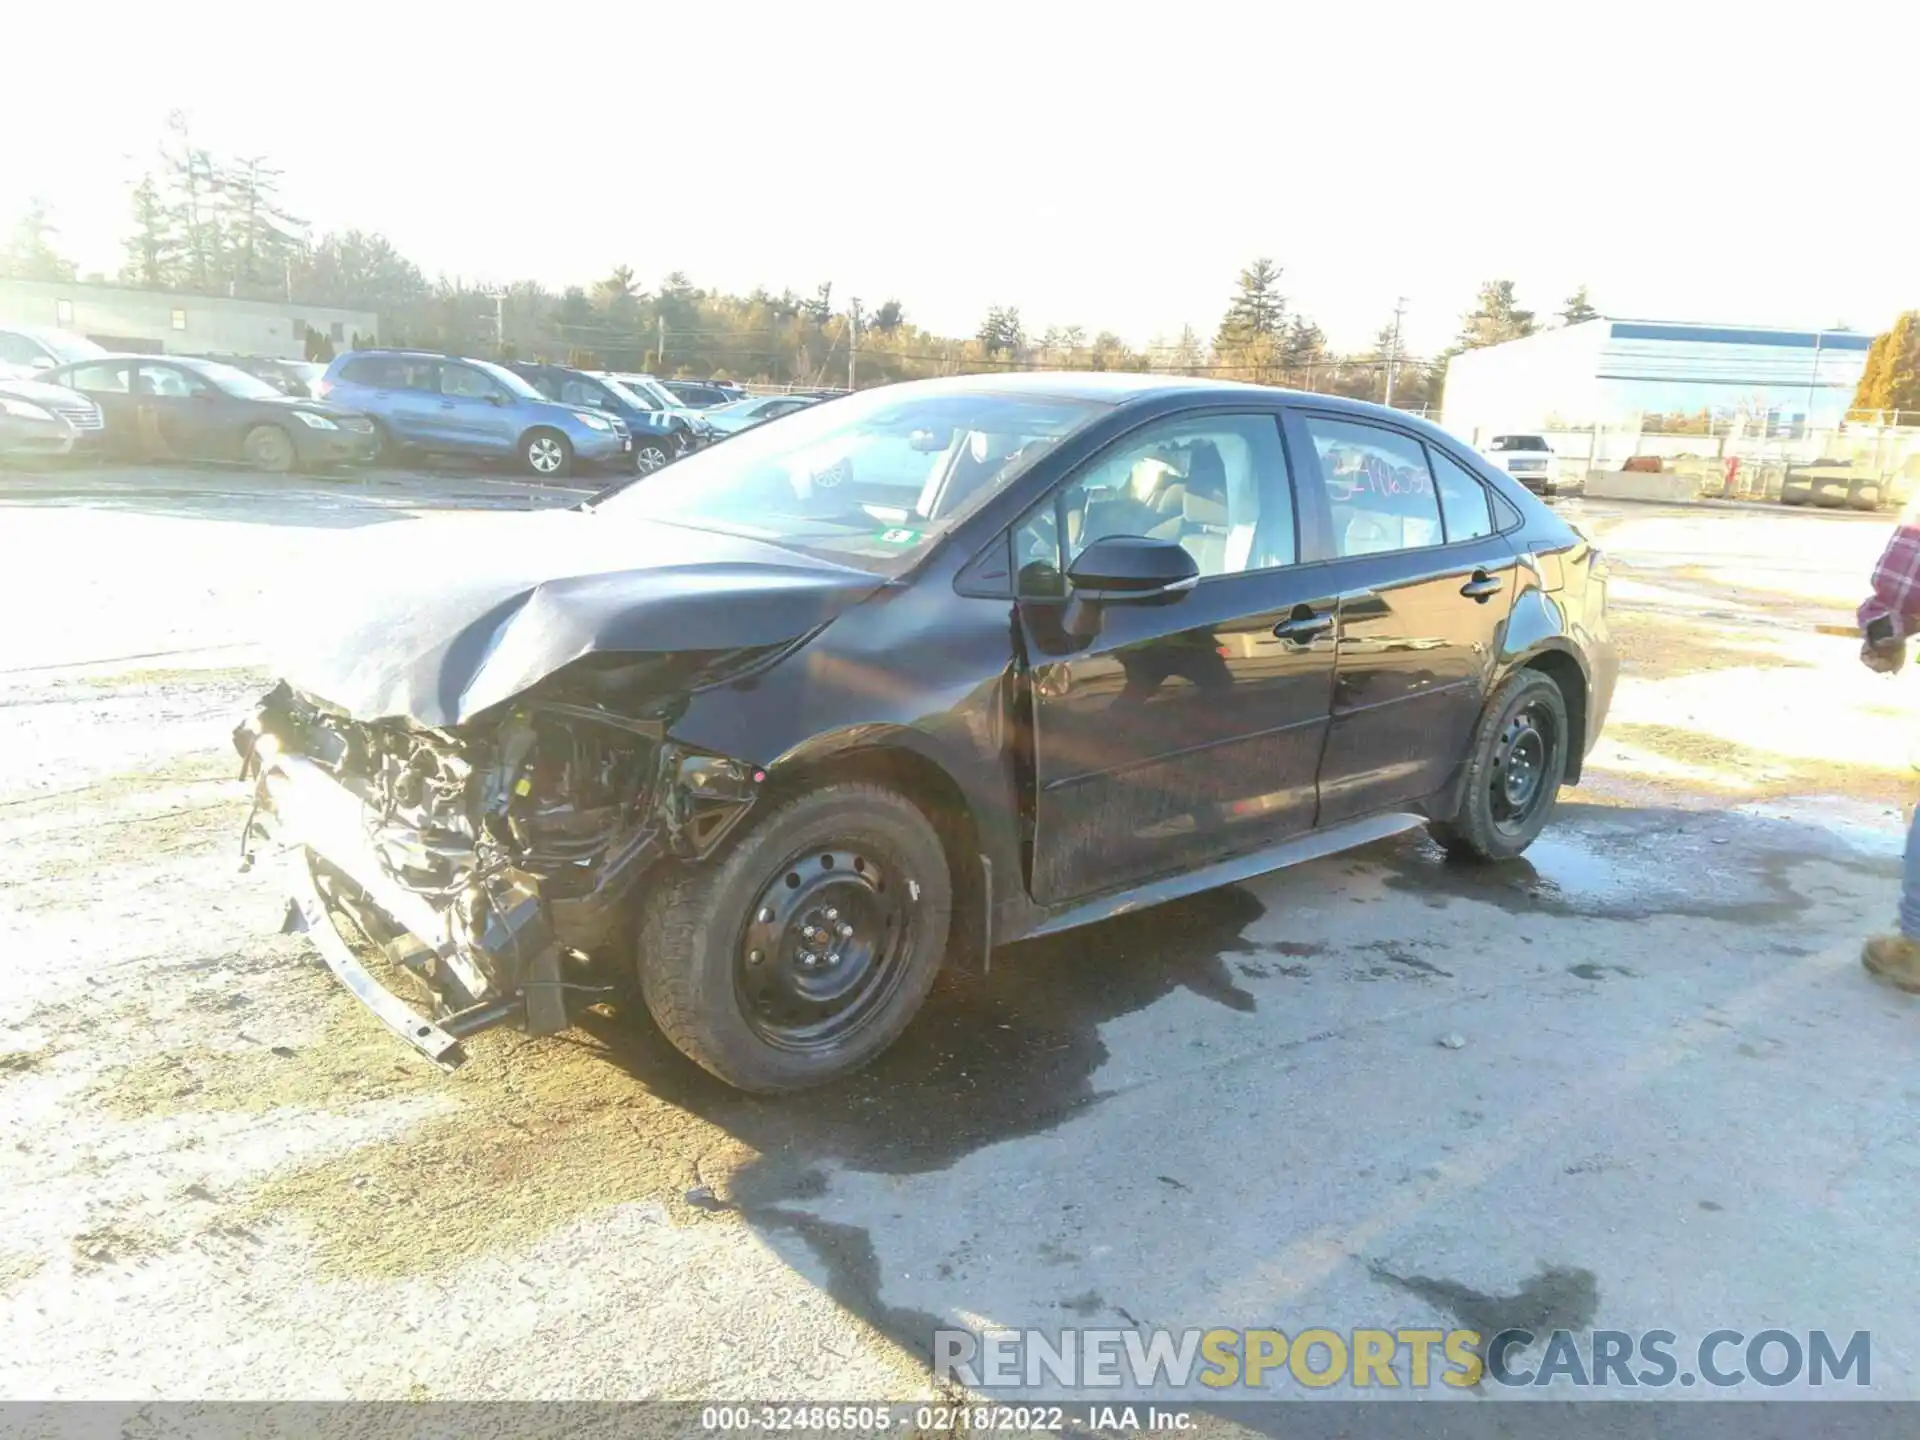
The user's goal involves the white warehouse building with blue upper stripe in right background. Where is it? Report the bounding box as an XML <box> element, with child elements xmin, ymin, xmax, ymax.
<box><xmin>1440</xmin><ymin>319</ymin><xmax>1872</xmax><ymax>445</ymax></box>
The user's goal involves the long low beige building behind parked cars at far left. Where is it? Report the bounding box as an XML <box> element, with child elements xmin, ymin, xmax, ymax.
<box><xmin>0</xmin><ymin>280</ymin><xmax>380</xmax><ymax>359</ymax></box>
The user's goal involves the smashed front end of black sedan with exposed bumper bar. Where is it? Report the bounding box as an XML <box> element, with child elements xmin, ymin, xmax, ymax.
<box><xmin>234</xmin><ymin>645</ymin><xmax>785</xmax><ymax>1069</ymax></box>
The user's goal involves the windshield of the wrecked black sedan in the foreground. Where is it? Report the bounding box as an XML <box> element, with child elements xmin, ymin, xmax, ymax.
<box><xmin>595</xmin><ymin>386</ymin><xmax>1106</xmax><ymax>574</ymax></box>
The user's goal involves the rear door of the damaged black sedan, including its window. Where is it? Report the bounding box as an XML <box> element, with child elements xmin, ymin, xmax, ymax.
<box><xmin>1288</xmin><ymin>411</ymin><xmax>1515</xmax><ymax>826</ymax></box>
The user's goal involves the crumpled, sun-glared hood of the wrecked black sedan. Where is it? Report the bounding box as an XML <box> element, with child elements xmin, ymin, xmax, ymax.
<box><xmin>269</xmin><ymin>511</ymin><xmax>883</xmax><ymax>728</ymax></box>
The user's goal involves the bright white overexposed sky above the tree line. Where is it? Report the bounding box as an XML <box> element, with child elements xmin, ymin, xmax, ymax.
<box><xmin>0</xmin><ymin>0</ymin><xmax>1920</xmax><ymax>355</ymax></box>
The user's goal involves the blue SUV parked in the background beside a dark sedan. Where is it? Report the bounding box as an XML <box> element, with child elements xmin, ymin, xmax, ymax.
<box><xmin>319</xmin><ymin>349</ymin><xmax>634</xmax><ymax>480</ymax></box>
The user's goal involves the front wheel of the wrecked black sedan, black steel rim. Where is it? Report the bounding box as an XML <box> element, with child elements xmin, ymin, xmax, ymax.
<box><xmin>637</xmin><ymin>783</ymin><xmax>952</xmax><ymax>1094</ymax></box>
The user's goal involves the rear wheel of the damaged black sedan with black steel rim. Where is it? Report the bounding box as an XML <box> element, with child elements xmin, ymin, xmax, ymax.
<box><xmin>1428</xmin><ymin>670</ymin><xmax>1571</xmax><ymax>860</ymax></box>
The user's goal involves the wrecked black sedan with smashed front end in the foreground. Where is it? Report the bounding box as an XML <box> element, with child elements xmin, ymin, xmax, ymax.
<box><xmin>234</xmin><ymin>374</ymin><xmax>1615</xmax><ymax>1091</ymax></box>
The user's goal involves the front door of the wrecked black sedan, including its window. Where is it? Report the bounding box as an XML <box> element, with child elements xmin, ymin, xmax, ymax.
<box><xmin>1014</xmin><ymin>409</ymin><xmax>1334</xmax><ymax>904</ymax></box>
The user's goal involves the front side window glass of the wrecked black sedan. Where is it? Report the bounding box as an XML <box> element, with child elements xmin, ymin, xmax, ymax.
<box><xmin>1014</xmin><ymin>413</ymin><xmax>1298</xmax><ymax>597</ymax></box>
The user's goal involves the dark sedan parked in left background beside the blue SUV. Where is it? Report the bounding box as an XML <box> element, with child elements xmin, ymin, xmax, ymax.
<box><xmin>44</xmin><ymin>355</ymin><xmax>376</xmax><ymax>470</ymax></box>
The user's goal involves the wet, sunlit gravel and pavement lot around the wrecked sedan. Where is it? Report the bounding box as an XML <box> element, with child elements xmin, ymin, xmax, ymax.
<box><xmin>0</xmin><ymin>458</ymin><xmax>1920</xmax><ymax>1400</ymax></box>
